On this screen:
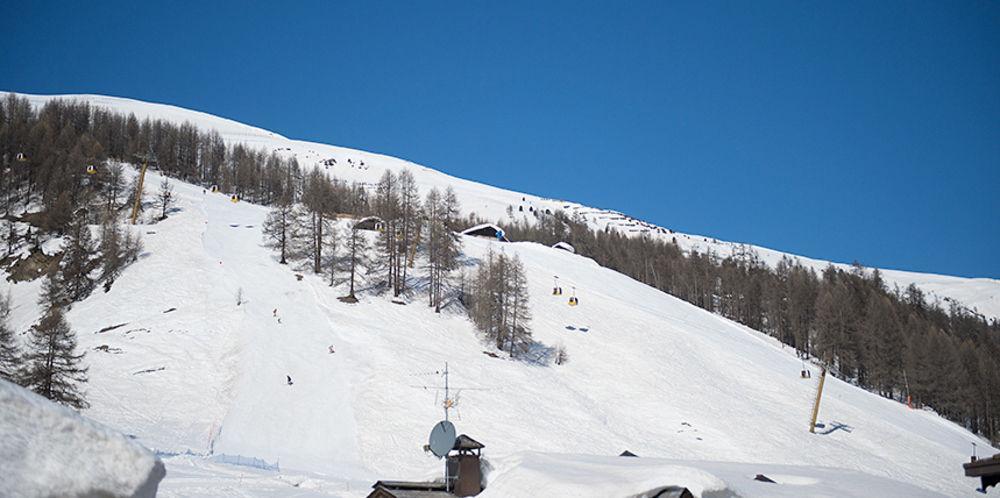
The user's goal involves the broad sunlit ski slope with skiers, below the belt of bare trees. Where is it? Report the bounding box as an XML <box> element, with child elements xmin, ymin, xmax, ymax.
<box><xmin>4</xmin><ymin>169</ymin><xmax>996</xmax><ymax>496</ymax></box>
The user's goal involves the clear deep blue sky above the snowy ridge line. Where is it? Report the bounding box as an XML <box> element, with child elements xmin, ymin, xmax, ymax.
<box><xmin>0</xmin><ymin>1</ymin><xmax>1000</xmax><ymax>278</ymax></box>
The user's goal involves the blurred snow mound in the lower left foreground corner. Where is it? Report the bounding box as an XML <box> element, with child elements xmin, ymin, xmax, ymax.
<box><xmin>0</xmin><ymin>380</ymin><xmax>163</xmax><ymax>498</ymax></box>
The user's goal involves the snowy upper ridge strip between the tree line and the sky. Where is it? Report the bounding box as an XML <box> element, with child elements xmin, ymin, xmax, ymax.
<box><xmin>9</xmin><ymin>94</ymin><xmax>1000</xmax><ymax>318</ymax></box>
